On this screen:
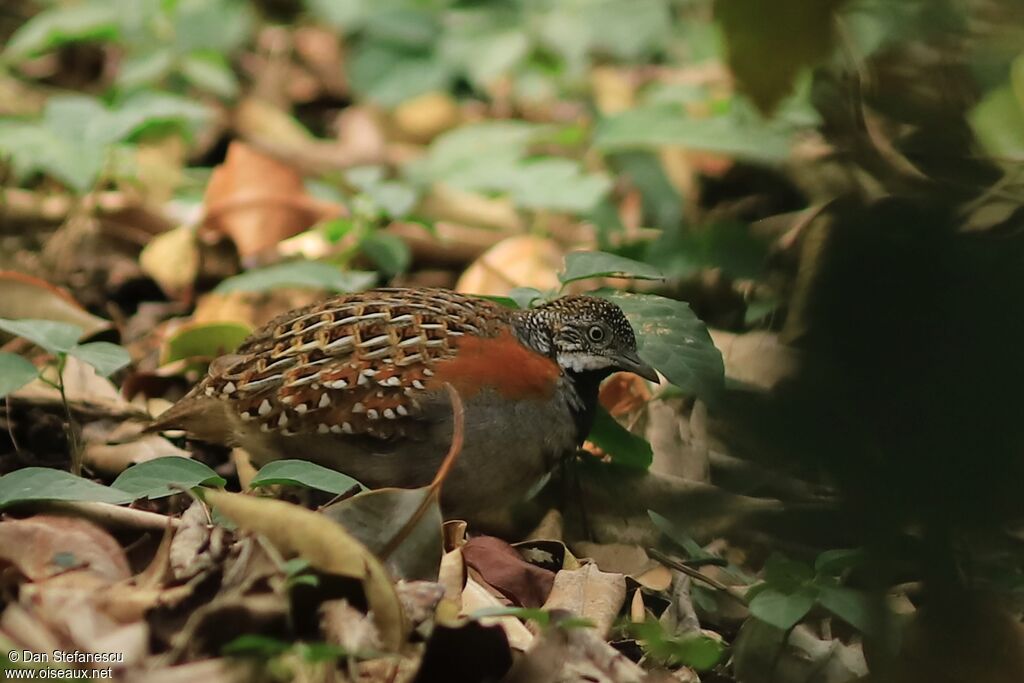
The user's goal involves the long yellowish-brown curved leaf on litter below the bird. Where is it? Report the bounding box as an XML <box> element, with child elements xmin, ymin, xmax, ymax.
<box><xmin>205</xmin><ymin>490</ymin><xmax>407</xmax><ymax>650</ymax></box>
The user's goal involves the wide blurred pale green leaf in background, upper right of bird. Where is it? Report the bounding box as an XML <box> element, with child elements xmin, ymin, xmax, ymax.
<box><xmin>594</xmin><ymin>104</ymin><xmax>791</xmax><ymax>162</ymax></box>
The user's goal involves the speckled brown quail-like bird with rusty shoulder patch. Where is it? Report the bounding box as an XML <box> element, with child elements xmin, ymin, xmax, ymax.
<box><xmin>147</xmin><ymin>288</ymin><xmax>659</xmax><ymax>518</ymax></box>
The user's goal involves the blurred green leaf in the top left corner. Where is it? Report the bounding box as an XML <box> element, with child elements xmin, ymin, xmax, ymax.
<box><xmin>4</xmin><ymin>2</ymin><xmax>118</xmax><ymax>59</ymax></box>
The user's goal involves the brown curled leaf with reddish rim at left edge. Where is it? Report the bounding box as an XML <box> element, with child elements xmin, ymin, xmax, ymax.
<box><xmin>0</xmin><ymin>270</ymin><xmax>111</xmax><ymax>337</ymax></box>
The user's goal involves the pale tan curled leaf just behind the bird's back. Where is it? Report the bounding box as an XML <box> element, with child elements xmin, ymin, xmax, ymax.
<box><xmin>456</xmin><ymin>234</ymin><xmax>564</xmax><ymax>296</ymax></box>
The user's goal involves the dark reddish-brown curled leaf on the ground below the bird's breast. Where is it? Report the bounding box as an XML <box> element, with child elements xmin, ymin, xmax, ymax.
<box><xmin>462</xmin><ymin>536</ymin><xmax>555</xmax><ymax>607</ymax></box>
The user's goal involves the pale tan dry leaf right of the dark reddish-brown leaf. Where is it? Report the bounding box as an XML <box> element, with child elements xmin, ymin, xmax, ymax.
<box><xmin>544</xmin><ymin>564</ymin><xmax>626</xmax><ymax>636</ymax></box>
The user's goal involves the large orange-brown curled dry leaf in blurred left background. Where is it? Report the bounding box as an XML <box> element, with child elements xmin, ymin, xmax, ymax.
<box><xmin>204</xmin><ymin>141</ymin><xmax>341</xmax><ymax>258</ymax></box>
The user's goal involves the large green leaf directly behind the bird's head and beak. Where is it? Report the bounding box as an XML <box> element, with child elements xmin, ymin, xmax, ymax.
<box><xmin>599</xmin><ymin>292</ymin><xmax>725</xmax><ymax>401</ymax></box>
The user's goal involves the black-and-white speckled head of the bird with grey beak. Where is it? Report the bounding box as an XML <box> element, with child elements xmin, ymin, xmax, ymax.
<box><xmin>518</xmin><ymin>295</ymin><xmax>658</xmax><ymax>382</ymax></box>
